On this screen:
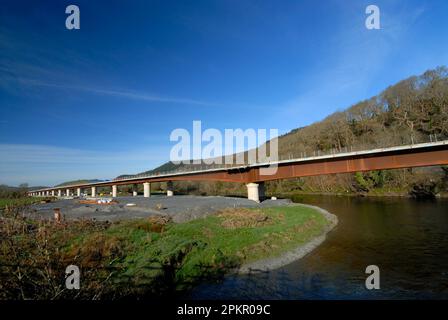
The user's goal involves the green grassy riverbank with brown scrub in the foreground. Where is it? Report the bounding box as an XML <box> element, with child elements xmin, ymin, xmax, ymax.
<box><xmin>0</xmin><ymin>206</ymin><xmax>328</xmax><ymax>299</ymax></box>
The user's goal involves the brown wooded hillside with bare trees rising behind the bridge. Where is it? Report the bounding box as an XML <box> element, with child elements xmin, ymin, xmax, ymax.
<box><xmin>113</xmin><ymin>67</ymin><xmax>448</xmax><ymax>195</ymax></box>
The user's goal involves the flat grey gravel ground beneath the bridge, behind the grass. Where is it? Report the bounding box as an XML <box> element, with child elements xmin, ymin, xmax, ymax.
<box><xmin>27</xmin><ymin>195</ymin><xmax>291</xmax><ymax>222</ymax></box>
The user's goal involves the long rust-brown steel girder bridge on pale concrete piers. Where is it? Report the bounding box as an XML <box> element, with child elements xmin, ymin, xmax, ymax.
<box><xmin>28</xmin><ymin>144</ymin><xmax>448</xmax><ymax>201</ymax></box>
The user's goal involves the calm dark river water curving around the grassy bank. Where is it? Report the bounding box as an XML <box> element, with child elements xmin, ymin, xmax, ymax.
<box><xmin>187</xmin><ymin>196</ymin><xmax>448</xmax><ymax>299</ymax></box>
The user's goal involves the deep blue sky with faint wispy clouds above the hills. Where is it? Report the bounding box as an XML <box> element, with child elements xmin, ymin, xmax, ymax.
<box><xmin>0</xmin><ymin>0</ymin><xmax>448</xmax><ymax>185</ymax></box>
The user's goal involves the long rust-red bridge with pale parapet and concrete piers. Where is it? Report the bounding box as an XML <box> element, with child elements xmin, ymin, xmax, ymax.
<box><xmin>28</xmin><ymin>140</ymin><xmax>448</xmax><ymax>202</ymax></box>
